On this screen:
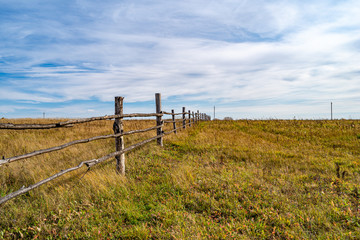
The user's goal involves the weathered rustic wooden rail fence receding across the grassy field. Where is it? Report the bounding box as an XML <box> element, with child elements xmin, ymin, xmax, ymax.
<box><xmin>0</xmin><ymin>93</ymin><xmax>210</xmax><ymax>205</ymax></box>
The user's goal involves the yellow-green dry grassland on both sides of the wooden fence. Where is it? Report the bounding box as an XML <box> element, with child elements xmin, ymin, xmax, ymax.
<box><xmin>0</xmin><ymin>119</ymin><xmax>360</xmax><ymax>239</ymax></box>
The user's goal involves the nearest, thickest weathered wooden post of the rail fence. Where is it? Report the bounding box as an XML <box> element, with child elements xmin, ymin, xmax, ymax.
<box><xmin>113</xmin><ymin>97</ymin><xmax>125</xmax><ymax>175</ymax></box>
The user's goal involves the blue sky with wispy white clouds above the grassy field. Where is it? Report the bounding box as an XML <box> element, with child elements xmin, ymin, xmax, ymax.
<box><xmin>0</xmin><ymin>0</ymin><xmax>360</xmax><ymax>119</ymax></box>
